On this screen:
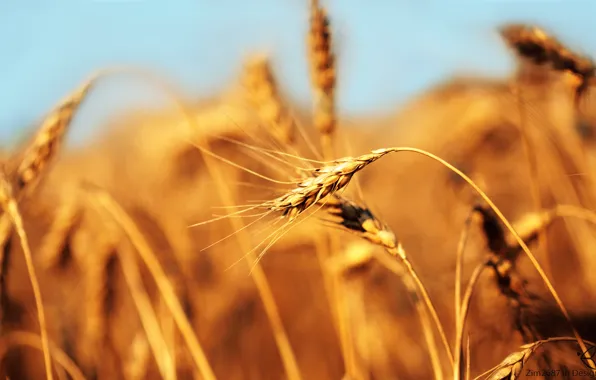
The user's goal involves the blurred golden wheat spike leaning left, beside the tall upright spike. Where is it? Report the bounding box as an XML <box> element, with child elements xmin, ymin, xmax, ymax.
<box><xmin>242</xmin><ymin>55</ymin><xmax>296</xmax><ymax>145</ymax></box>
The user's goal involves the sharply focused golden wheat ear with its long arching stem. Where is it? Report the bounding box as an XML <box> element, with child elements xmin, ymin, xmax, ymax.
<box><xmin>261</xmin><ymin>147</ymin><xmax>596</xmax><ymax>366</ymax></box>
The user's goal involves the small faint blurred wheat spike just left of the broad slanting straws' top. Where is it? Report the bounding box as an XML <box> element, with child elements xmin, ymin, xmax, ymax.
<box><xmin>37</xmin><ymin>201</ymin><xmax>81</xmax><ymax>270</ymax></box>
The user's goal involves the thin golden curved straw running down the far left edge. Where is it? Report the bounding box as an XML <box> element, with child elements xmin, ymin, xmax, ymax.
<box><xmin>0</xmin><ymin>172</ymin><xmax>53</xmax><ymax>380</ymax></box>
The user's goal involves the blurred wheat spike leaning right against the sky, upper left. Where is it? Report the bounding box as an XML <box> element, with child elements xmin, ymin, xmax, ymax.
<box><xmin>14</xmin><ymin>76</ymin><xmax>97</xmax><ymax>193</ymax></box>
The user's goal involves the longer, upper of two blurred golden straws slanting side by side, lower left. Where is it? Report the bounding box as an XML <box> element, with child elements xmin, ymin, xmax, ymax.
<box><xmin>86</xmin><ymin>186</ymin><xmax>215</xmax><ymax>380</ymax></box>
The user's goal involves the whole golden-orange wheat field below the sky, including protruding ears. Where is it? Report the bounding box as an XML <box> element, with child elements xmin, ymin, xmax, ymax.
<box><xmin>0</xmin><ymin>1</ymin><xmax>596</xmax><ymax>380</ymax></box>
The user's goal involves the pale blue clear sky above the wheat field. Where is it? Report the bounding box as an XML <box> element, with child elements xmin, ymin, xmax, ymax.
<box><xmin>0</xmin><ymin>0</ymin><xmax>596</xmax><ymax>146</ymax></box>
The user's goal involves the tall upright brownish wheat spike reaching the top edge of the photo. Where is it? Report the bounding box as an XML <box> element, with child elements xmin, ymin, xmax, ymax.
<box><xmin>308</xmin><ymin>0</ymin><xmax>336</xmax><ymax>147</ymax></box>
